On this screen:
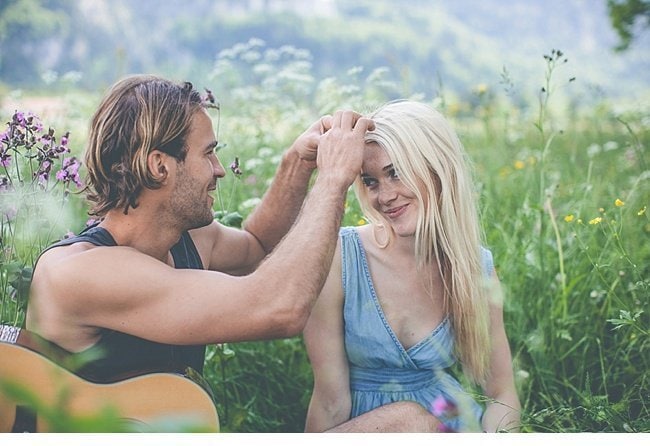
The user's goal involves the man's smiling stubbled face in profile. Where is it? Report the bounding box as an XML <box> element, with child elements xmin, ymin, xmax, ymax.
<box><xmin>171</xmin><ymin>110</ymin><xmax>226</xmax><ymax>229</ymax></box>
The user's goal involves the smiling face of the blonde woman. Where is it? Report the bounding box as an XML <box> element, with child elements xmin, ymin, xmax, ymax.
<box><xmin>361</xmin><ymin>143</ymin><xmax>419</xmax><ymax>237</ymax></box>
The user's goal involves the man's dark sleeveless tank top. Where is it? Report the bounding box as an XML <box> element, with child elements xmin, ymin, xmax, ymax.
<box><xmin>38</xmin><ymin>226</ymin><xmax>205</xmax><ymax>382</ymax></box>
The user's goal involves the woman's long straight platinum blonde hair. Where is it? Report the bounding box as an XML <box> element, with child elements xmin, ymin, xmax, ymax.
<box><xmin>355</xmin><ymin>101</ymin><xmax>490</xmax><ymax>383</ymax></box>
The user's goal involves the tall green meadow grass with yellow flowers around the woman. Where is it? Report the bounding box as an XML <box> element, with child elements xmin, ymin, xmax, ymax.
<box><xmin>2</xmin><ymin>41</ymin><xmax>650</xmax><ymax>432</ymax></box>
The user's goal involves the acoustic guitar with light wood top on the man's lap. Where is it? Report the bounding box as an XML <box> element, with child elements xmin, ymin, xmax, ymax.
<box><xmin>0</xmin><ymin>325</ymin><xmax>219</xmax><ymax>432</ymax></box>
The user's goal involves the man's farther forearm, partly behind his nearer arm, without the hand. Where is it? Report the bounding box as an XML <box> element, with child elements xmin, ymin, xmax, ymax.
<box><xmin>243</xmin><ymin>149</ymin><xmax>314</xmax><ymax>253</ymax></box>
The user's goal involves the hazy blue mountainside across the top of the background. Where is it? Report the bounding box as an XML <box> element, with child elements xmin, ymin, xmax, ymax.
<box><xmin>0</xmin><ymin>0</ymin><xmax>650</xmax><ymax>103</ymax></box>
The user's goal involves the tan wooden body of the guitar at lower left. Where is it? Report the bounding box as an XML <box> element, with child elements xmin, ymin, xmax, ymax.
<box><xmin>0</xmin><ymin>330</ymin><xmax>219</xmax><ymax>432</ymax></box>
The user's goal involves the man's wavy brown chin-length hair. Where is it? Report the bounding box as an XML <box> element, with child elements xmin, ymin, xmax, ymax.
<box><xmin>85</xmin><ymin>75</ymin><xmax>202</xmax><ymax>217</ymax></box>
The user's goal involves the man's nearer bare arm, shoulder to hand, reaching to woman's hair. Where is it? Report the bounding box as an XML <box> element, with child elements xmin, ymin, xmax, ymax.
<box><xmin>32</xmin><ymin>113</ymin><xmax>371</xmax><ymax>344</ymax></box>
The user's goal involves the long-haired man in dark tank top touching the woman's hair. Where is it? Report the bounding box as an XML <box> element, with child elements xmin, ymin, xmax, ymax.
<box><xmin>26</xmin><ymin>76</ymin><xmax>435</xmax><ymax>431</ymax></box>
